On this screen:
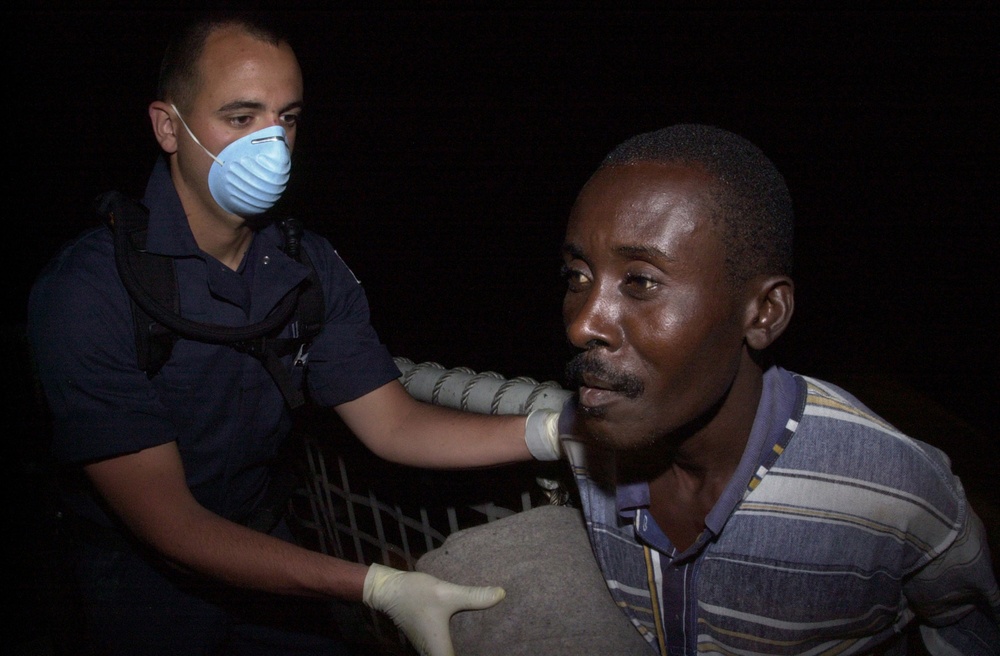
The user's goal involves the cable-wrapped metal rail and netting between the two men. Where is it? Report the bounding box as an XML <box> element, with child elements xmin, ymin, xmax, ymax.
<box><xmin>292</xmin><ymin>358</ymin><xmax>571</xmax><ymax>645</ymax></box>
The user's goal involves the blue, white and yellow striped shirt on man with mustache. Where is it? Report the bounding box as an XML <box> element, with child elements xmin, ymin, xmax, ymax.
<box><xmin>563</xmin><ymin>368</ymin><xmax>1000</xmax><ymax>656</ymax></box>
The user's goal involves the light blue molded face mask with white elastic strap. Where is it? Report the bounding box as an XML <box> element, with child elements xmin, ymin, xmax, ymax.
<box><xmin>171</xmin><ymin>105</ymin><xmax>292</xmax><ymax>216</ymax></box>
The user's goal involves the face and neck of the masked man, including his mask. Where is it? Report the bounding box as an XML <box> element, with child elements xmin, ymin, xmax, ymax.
<box><xmin>149</xmin><ymin>22</ymin><xmax>303</xmax><ymax>268</ymax></box>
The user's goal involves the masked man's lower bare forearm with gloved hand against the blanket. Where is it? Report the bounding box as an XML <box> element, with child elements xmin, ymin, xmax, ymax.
<box><xmin>84</xmin><ymin>440</ymin><xmax>504</xmax><ymax>656</ymax></box>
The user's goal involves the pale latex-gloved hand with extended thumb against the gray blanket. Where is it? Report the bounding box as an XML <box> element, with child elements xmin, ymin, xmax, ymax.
<box><xmin>362</xmin><ymin>563</ymin><xmax>506</xmax><ymax>656</ymax></box>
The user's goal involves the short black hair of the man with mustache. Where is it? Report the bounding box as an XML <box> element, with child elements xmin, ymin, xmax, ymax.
<box><xmin>599</xmin><ymin>124</ymin><xmax>794</xmax><ymax>285</ymax></box>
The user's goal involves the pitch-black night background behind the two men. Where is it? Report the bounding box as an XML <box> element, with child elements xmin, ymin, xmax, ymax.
<box><xmin>2</xmin><ymin>2</ymin><xmax>1000</xmax><ymax>648</ymax></box>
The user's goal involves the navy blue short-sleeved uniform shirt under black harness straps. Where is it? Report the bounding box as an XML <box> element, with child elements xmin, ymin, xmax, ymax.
<box><xmin>28</xmin><ymin>159</ymin><xmax>399</xmax><ymax>523</ymax></box>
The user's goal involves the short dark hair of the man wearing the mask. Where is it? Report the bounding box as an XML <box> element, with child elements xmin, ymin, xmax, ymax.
<box><xmin>156</xmin><ymin>11</ymin><xmax>288</xmax><ymax>109</ymax></box>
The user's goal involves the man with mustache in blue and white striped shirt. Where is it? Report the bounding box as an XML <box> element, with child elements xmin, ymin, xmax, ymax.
<box><xmin>561</xmin><ymin>125</ymin><xmax>1000</xmax><ymax>655</ymax></box>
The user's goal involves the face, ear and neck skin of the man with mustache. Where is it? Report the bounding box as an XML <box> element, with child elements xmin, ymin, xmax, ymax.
<box><xmin>563</xmin><ymin>162</ymin><xmax>794</xmax><ymax>550</ymax></box>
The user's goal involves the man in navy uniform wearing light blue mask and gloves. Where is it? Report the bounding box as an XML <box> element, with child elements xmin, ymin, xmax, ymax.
<box><xmin>29</xmin><ymin>10</ymin><xmax>560</xmax><ymax>656</ymax></box>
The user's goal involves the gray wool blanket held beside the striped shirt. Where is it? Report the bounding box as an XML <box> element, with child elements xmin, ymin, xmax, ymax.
<box><xmin>416</xmin><ymin>506</ymin><xmax>655</xmax><ymax>656</ymax></box>
